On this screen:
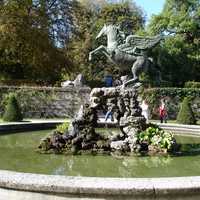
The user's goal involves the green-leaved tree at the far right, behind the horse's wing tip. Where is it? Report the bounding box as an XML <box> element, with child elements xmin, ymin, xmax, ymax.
<box><xmin>148</xmin><ymin>0</ymin><xmax>200</xmax><ymax>86</ymax></box>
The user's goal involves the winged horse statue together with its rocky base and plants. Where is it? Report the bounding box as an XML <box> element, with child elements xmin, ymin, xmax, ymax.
<box><xmin>39</xmin><ymin>24</ymin><xmax>177</xmax><ymax>154</ymax></box>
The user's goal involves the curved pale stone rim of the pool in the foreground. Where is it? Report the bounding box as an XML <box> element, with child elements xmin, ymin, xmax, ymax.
<box><xmin>0</xmin><ymin>170</ymin><xmax>200</xmax><ymax>196</ymax></box>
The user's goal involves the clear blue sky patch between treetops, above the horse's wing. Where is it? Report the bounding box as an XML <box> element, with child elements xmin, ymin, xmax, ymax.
<box><xmin>134</xmin><ymin>0</ymin><xmax>165</xmax><ymax>20</ymax></box>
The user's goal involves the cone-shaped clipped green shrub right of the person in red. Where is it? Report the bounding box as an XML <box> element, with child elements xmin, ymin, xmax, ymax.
<box><xmin>177</xmin><ymin>97</ymin><xmax>196</xmax><ymax>124</ymax></box>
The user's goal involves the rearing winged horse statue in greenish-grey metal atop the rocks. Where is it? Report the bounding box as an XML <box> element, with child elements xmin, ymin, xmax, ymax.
<box><xmin>89</xmin><ymin>24</ymin><xmax>162</xmax><ymax>87</ymax></box>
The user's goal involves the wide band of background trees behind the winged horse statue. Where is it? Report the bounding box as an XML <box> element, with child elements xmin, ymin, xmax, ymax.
<box><xmin>0</xmin><ymin>0</ymin><xmax>200</xmax><ymax>86</ymax></box>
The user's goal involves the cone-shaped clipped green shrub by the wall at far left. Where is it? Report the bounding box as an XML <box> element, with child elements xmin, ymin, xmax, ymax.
<box><xmin>3</xmin><ymin>93</ymin><xmax>23</xmax><ymax>122</ymax></box>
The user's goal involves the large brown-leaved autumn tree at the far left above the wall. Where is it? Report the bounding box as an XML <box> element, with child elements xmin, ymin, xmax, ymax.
<box><xmin>0</xmin><ymin>0</ymin><xmax>72</xmax><ymax>83</ymax></box>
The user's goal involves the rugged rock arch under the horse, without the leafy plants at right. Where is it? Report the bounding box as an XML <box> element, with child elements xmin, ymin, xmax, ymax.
<box><xmin>39</xmin><ymin>87</ymin><xmax>156</xmax><ymax>153</ymax></box>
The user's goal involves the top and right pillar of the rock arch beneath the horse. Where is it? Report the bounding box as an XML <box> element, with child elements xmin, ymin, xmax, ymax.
<box><xmin>90</xmin><ymin>87</ymin><xmax>146</xmax><ymax>152</ymax></box>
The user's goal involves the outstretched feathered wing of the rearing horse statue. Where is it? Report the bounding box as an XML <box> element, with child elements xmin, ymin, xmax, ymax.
<box><xmin>126</xmin><ymin>35</ymin><xmax>162</xmax><ymax>50</ymax></box>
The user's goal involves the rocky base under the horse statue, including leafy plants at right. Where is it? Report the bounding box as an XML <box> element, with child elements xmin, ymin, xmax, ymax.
<box><xmin>40</xmin><ymin>87</ymin><xmax>176</xmax><ymax>155</ymax></box>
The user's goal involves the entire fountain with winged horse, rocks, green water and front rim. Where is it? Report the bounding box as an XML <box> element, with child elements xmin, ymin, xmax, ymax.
<box><xmin>0</xmin><ymin>22</ymin><xmax>200</xmax><ymax>200</ymax></box>
